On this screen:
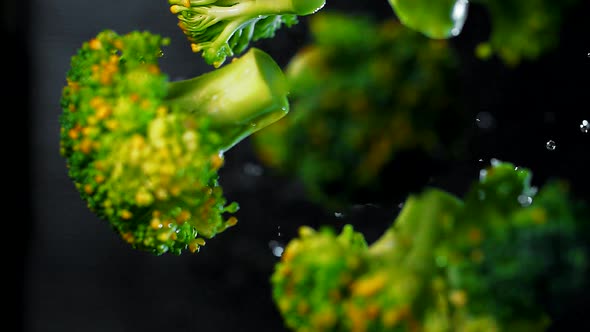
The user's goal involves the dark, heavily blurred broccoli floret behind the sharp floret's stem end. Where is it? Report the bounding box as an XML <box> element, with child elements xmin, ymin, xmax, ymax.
<box><xmin>252</xmin><ymin>10</ymin><xmax>464</xmax><ymax>209</ymax></box>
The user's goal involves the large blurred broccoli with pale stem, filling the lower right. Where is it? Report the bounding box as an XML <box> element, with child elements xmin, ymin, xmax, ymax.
<box><xmin>271</xmin><ymin>161</ymin><xmax>590</xmax><ymax>332</ymax></box>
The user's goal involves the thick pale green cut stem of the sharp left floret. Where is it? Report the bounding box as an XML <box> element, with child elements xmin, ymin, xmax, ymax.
<box><xmin>165</xmin><ymin>48</ymin><xmax>289</xmax><ymax>152</ymax></box>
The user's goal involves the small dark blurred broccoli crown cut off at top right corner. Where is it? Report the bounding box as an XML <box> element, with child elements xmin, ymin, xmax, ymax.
<box><xmin>474</xmin><ymin>0</ymin><xmax>578</xmax><ymax>66</ymax></box>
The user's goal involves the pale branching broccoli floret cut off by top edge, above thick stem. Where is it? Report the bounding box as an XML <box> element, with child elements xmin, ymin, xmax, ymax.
<box><xmin>168</xmin><ymin>0</ymin><xmax>325</xmax><ymax>67</ymax></box>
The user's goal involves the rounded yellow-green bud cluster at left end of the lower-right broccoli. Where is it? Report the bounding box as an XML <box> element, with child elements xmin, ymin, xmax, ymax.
<box><xmin>272</xmin><ymin>225</ymin><xmax>367</xmax><ymax>331</ymax></box>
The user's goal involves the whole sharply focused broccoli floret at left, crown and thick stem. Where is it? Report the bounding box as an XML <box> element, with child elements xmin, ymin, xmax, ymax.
<box><xmin>60</xmin><ymin>30</ymin><xmax>289</xmax><ymax>254</ymax></box>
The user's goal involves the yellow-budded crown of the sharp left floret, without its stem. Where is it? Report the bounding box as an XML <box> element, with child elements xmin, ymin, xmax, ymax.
<box><xmin>60</xmin><ymin>30</ymin><xmax>237</xmax><ymax>254</ymax></box>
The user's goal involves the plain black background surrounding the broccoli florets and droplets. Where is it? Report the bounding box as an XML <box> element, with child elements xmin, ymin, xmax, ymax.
<box><xmin>9</xmin><ymin>0</ymin><xmax>590</xmax><ymax>332</ymax></box>
